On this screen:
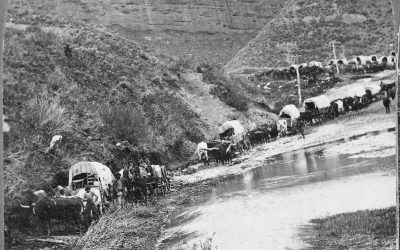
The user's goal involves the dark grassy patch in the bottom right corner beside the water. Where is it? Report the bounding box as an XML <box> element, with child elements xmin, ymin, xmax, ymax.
<box><xmin>302</xmin><ymin>207</ymin><xmax>396</xmax><ymax>249</ymax></box>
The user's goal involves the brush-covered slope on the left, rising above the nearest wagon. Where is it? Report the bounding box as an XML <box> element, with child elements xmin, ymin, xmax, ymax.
<box><xmin>4</xmin><ymin>26</ymin><xmax>205</xmax><ymax>195</ymax></box>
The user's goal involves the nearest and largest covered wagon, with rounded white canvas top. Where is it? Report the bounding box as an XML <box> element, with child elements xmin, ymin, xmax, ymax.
<box><xmin>68</xmin><ymin>161</ymin><xmax>114</xmax><ymax>212</ymax></box>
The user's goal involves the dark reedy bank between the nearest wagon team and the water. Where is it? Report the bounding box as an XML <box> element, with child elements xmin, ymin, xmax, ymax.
<box><xmin>74</xmin><ymin>180</ymin><xmax>222</xmax><ymax>249</ymax></box>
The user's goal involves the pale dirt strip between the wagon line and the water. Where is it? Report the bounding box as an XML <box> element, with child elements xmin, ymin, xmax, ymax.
<box><xmin>174</xmin><ymin>101</ymin><xmax>396</xmax><ymax>183</ymax></box>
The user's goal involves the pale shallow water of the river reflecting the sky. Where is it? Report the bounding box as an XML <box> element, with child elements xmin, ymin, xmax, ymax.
<box><xmin>161</xmin><ymin>132</ymin><xmax>396</xmax><ymax>249</ymax></box>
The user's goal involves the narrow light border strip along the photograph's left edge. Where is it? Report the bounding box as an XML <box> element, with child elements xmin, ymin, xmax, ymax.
<box><xmin>0</xmin><ymin>0</ymin><xmax>8</xmax><ymax>246</ymax></box>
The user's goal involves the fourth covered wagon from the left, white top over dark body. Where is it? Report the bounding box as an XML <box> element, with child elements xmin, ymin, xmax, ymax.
<box><xmin>300</xmin><ymin>95</ymin><xmax>334</xmax><ymax>121</ymax></box>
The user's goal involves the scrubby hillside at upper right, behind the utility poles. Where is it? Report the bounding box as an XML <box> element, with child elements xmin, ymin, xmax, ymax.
<box><xmin>225</xmin><ymin>0</ymin><xmax>394</xmax><ymax>72</ymax></box>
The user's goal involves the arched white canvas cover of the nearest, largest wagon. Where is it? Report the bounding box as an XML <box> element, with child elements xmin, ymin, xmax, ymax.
<box><xmin>68</xmin><ymin>161</ymin><xmax>114</xmax><ymax>189</ymax></box>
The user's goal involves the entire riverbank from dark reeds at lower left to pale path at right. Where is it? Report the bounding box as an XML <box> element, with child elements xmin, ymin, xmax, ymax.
<box><xmin>75</xmin><ymin>102</ymin><xmax>396</xmax><ymax>249</ymax></box>
